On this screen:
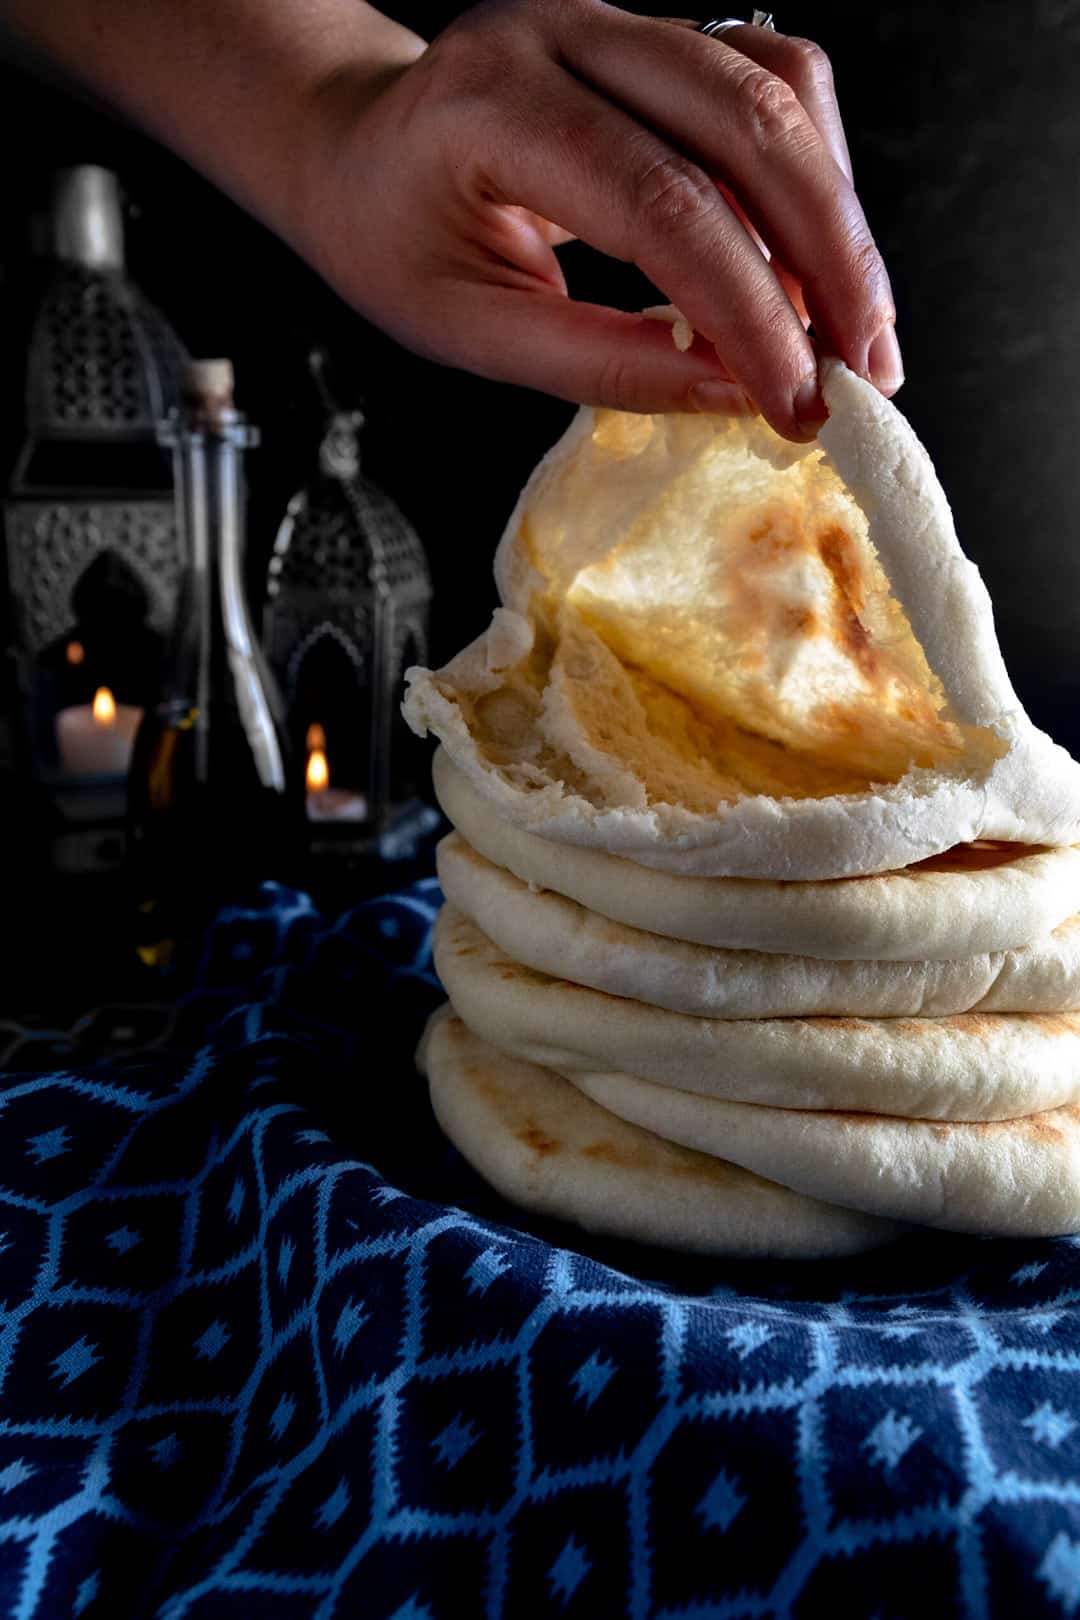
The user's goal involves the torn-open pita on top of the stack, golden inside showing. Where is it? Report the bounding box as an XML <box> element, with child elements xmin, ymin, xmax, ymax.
<box><xmin>405</xmin><ymin>361</ymin><xmax>1080</xmax><ymax>880</ymax></box>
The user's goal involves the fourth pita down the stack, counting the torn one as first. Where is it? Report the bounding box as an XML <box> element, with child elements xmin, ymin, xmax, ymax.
<box><xmin>434</xmin><ymin>906</ymin><xmax>1080</xmax><ymax>1119</ymax></box>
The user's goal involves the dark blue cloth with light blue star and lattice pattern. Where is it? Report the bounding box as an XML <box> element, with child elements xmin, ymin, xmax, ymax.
<box><xmin>0</xmin><ymin>881</ymin><xmax>1080</xmax><ymax>1620</ymax></box>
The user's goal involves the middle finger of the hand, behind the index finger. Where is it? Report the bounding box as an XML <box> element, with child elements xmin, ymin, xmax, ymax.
<box><xmin>557</xmin><ymin>6</ymin><xmax>902</xmax><ymax>392</ymax></box>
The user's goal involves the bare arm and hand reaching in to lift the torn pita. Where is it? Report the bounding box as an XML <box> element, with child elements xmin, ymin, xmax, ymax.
<box><xmin>0</xmin><ymin>0</ymin><xmax>902</xmax><ymax>437</ymax></box>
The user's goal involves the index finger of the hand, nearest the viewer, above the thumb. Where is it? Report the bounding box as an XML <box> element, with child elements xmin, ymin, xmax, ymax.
<box><xmin>478</xmin><ymin>65</ymin><xmax>821</xmax><ymax>439</ymax></box>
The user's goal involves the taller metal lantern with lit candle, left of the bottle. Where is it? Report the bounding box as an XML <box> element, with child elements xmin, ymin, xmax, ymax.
<box><xmin>3</xmin><ymin>167</ymin><xmax>186</xmax><ymax>870</ymax></box>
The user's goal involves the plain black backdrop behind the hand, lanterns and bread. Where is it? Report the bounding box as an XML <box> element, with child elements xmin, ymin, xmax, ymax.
<box><xmin>0</xmin><ymin>0</ymin><xmax>1080</xmax><ymax>747</ymax></box>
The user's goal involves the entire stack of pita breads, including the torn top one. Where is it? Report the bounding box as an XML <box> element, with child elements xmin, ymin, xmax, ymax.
<box><xmin>405</xmin><ymin>363</ymin><xmax>1080</xmax><ymax>1256</ymax></box>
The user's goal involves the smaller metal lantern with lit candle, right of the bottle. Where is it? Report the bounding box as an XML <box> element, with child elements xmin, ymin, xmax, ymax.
<box><xmin>264</xmin><ymin>355</ymin><xmax>437</xmax><ymax>859</ymax></box>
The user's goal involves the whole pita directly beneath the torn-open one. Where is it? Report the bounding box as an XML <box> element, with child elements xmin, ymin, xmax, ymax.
<box><xmin>432</xmin><ymin>748</ymin><xmax>1080</xmax><ymax>962</ymax></box>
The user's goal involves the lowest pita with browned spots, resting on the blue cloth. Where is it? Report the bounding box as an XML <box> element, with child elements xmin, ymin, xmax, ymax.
<box><xmin>419</xmin><ymin>1014</ymin><xmax>899</xmax><ymax>1259</ymax></box>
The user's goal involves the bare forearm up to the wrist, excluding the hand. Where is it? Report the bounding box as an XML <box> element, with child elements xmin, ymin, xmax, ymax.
<box><xmin>0</xmin><ymin>0</ymin><xmax>424</xmax><ymax>241</ymax></box>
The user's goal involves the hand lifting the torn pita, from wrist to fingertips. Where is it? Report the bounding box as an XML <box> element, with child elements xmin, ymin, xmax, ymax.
<box><xmin>297</xmin><ymin>0</ymin><xmax>902</xmax><ymax>439</ymax></box>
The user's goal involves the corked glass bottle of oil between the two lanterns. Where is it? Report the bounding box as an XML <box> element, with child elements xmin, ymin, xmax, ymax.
<box><xmin>128</xmin><ymin>360</ymin><xmax>303</xmax><ymax>969</ymax></box>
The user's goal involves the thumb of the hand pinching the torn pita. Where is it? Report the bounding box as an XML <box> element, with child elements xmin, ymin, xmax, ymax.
<box><xmin>427</xmin><ymin>284</ymin><xmax>753</xmax><ymax>415</ymax></box>
